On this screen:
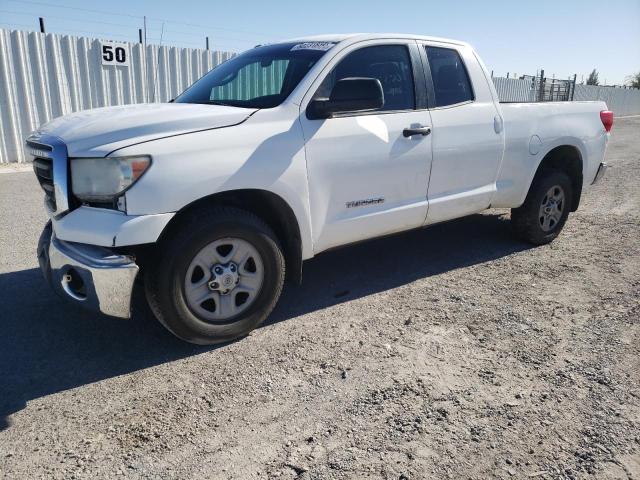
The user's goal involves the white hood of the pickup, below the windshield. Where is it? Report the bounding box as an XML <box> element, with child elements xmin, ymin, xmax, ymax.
<box><xmin>37</xmin><ymin>103</ymin><xmax>256</xmax><ymax>157</ymax></box>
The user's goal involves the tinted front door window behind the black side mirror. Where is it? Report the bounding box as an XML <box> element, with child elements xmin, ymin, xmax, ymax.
<box><xmin>314</xmin><ymin>45</ymin><xmax>416</xmax><ymax>111</ymax></box>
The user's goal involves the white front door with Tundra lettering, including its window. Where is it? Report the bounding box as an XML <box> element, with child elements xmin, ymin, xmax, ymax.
<box><xmin>300</xmin><ymin>41</ymin><xmax>431</xmax><ymax>253</ymax></box>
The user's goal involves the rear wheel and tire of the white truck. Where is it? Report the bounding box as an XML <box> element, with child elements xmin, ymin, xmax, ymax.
<box><xmin>511</xmin><ymin>170</ymin><xmax>573</xmax><ymax>245</ymax></box>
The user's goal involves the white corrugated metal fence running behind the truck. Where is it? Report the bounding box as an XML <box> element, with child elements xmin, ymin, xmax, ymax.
<box><xmin>0</xmin><ymin>29</ymin><xmax>640</xmax><ymax>163</ymax></box>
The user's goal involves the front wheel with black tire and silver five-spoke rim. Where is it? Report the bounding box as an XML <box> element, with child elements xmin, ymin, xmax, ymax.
<box><xmin>145</xmin><ymin>207</ymin><xmax>285</xmax><ymax>345</ymax></box>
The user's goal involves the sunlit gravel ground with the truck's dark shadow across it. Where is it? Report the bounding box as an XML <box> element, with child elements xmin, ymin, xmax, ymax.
<box><xmin>0</xmin><ymin>118</ymin><xmax>640</xmax><ymax>479</ymax></box>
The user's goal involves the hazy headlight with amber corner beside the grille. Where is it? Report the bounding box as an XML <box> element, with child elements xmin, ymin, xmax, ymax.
<box><xmin>71</xmin><ymin>156</ymin><xmax>151</xmax><ymax>202</ymax></box>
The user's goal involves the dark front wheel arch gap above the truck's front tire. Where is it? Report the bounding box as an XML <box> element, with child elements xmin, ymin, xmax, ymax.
<box><xmin>157</xmin><ymin>188</ymin><xmax>303</xmax><ymax>283</ymax></box>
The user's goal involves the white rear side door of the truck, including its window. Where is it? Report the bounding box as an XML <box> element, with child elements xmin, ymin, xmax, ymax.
<box><xmin>421</xmin><ymin>42</ymin><xmax>504</xmax><ymax>223</ymax></box>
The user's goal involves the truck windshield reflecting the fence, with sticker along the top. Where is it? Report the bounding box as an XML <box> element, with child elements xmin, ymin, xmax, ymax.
<box><xmin>175</xmin><ymin>42</ymin><xmax>335</xmax><ymax>108</ymax></box>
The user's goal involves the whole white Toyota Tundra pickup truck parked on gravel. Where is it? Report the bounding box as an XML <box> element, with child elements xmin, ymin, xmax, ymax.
<box><xmin>32</xmin><ymin>34</ymin><xmax>613</xmax><ymax>344</ymax></box>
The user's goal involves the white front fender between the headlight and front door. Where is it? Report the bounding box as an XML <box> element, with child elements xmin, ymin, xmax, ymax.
<box><xmin>118</xmin><ymin>106</ymin><xmax>313</xmax><ymax>259</ymax></box>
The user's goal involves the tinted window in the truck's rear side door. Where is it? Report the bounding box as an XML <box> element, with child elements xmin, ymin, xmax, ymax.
<box><xmin>426</xmin><ymin>47</ymin><xmax>473</xmax><ymax>107</ymax></box>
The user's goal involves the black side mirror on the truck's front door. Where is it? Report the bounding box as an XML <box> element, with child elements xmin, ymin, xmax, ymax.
<box><xmin>307</xmin><ymin>77</ymin><xmax>384</xmax><ymax>120</ymax></box>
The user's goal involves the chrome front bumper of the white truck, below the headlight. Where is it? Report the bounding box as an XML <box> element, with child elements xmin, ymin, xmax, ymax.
<box><xmin>38</xmin><ymin>223</ymin><xmax>138</xmax><ymax>318</ymax></box>
